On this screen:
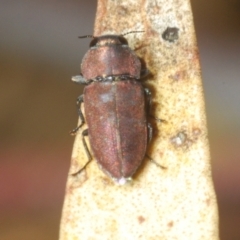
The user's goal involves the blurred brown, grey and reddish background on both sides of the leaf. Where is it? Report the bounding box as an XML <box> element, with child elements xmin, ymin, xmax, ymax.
<box><xmin>0</xmin><ymin>0</ymin><xmax>240</xmax><ymax>240</ymax></box>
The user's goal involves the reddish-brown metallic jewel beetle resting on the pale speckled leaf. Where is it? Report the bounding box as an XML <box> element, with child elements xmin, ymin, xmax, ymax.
<box><xmin>72</xmin><ymin>32</ymin><xmax>152</xmax><ymax>184</ymax></box>
